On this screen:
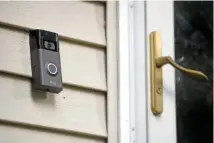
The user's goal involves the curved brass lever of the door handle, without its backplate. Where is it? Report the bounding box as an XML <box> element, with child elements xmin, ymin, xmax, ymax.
<box><xmin>156</xmin><ymin>56</ymin><xmax>208</xmax><ymax>81</ymax></box>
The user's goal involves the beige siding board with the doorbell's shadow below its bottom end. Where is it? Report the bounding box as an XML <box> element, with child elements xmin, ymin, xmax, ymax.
<box><xmin>0</xmin><ymin>74</ymin><xmax>107</xmax><ymax>137</ymax></box>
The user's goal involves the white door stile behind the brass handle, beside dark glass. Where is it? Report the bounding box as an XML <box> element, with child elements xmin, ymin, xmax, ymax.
<box><xmin>146</xmin><ymin>1</ymin><xmax>177</xmax><ymax>143</ymax></box>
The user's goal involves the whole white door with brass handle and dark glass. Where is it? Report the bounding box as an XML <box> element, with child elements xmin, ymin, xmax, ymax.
<box><xmin>145</xmin><ymin>1</ymin><xmax>213</xmax><ymax>143</ymax></box>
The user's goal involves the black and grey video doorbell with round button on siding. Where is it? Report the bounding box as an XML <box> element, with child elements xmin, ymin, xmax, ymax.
<box><xmin>29</xmin><ymin>29</ymin><xmax>63</xmax><ymax>93</ymax></box>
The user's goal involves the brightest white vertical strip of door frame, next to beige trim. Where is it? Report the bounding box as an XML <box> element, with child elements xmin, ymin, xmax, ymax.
<box><xmin>118</xmin><ymin>0</ymin><xmax>131</xmax><ymax>143</ymax></box>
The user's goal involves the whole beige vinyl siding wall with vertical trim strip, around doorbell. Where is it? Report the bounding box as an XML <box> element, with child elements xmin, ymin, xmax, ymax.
<box><xmin>0</xmin><ymin>1</ymin><xmax>117</xmax><ymax>143</ymax></box>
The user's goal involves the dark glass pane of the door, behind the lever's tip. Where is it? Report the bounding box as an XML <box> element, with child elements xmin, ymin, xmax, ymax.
<box><xmin>174</xmin><ymin>1</ymin><xmax>213</xmax><ymax>143</ymax></box>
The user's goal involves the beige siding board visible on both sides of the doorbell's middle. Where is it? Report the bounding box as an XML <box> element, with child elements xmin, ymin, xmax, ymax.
<box><xmin>0</xmin><ymin>27</ymin><xmax>106</xmax><ymax>91</ymax></box>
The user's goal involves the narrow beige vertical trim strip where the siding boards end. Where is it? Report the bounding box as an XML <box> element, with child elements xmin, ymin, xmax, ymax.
<box><xmin>106</xmin><ymin>1</ymin><xmax>119</xmax><ymax>143</ymax></box>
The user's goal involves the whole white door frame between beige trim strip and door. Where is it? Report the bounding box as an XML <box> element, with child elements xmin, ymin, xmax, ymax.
<box><xmin>117</xmin><ymin>0</ymin><xmax>148</xmax><ymax>143</ymax></box>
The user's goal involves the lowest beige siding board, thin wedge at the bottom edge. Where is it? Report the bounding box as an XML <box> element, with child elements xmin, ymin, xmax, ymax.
<box><xmin>0</xmin><ymin>124</ymin><xmax>105</xmax><ymax>143</ymax></box>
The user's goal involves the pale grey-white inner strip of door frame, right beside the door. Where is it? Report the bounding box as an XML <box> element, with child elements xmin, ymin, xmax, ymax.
<box><xmin>133</xmin><ymin>1</ymin><xmax>149</xmax><ymax>143</ymax></box>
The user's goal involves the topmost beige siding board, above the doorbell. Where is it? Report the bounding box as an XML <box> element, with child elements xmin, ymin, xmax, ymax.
<box><xmin>0</xmin><ymin>1</ymin><xmax>106</xmax><ymax>47</ymax></box>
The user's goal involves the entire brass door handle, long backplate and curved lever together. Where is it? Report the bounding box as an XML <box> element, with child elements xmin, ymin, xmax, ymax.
<box><xmin>150</xmin><ymin>31</ymin><xmax>208</xmax><ymax>115</ymax></box>
